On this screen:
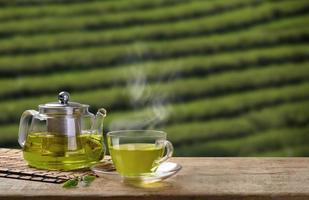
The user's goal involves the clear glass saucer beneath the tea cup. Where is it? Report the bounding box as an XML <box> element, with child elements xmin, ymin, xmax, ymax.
<box><xmin>91</xmin><ymin>162</ymin><xmax>182</xmax><ymax>183</ymax></box>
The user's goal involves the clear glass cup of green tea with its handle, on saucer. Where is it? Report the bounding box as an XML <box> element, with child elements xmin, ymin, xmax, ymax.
<box><xmin>107</xmin><ymin>130</ymin><xmax>173</xmax><ymax>177</ymax></box>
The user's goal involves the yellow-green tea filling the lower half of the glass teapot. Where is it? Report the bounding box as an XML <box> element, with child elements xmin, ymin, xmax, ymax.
<box><xmin>23</xmin><ymin>132</ymin><xmax>104</xmax><ymax>170</ymax></box>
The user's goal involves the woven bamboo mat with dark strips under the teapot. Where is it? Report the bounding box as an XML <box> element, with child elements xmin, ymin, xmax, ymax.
<box><xmin>0</xmin><ymin>148</ymin><xmax>112</xmax><ymax>183</ymax></box>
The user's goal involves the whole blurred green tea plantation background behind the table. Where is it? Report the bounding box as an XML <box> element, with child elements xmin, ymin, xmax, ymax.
<box><xmin>0</xmin><ymin>0</ymin><xmax>309</xmax><ymax>156</ymax></box>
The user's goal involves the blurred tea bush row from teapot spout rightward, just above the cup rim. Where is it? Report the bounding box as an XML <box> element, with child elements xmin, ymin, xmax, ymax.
<box><xmin>105</xmin><ymin>82</ymin><xmax>309</xmax><ymax>128</ymax></box>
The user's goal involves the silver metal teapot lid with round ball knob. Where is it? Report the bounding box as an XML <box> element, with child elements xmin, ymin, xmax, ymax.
<box><xmin>39</xmin><ymin>91</ymin><xmax>89</xmax><ymax>115</ymax></box>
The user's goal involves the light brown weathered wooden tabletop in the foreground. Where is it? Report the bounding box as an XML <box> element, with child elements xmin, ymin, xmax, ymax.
<box><xmin>0</xmin><ymin>158</ymin><xmax>309</xmax><ymax>200</ymax></box>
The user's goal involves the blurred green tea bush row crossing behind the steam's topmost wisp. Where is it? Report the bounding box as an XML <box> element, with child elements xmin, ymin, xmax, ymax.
<box><xmin>0</xmin><ymin>29</ymin><xmax>309</xmax><ymax>76</ymax></box>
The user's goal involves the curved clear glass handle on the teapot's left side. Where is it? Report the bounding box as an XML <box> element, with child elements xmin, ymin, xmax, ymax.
<box><xmin>18</xmin><ymin>110</ymin><xmax>39</xmax><ymax>147</ymax></box>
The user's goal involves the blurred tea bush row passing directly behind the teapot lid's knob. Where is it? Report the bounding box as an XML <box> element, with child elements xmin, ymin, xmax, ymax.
<box><xmin>0</xmin><ymin>63</ymin><xmax>309</xmax><ymax>123</ymax></box>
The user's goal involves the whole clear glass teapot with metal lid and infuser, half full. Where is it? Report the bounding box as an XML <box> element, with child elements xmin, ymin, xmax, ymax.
<box><xmin>18</xmin><ymin>92</ymin><xmax>106</xmax><ymax>170</ymax></box>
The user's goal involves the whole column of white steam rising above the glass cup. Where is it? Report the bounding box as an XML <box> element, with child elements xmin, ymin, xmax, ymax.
<box><xmin>109</xmin><ymin>43</ymin><xmax>176</xmax><ymax>131</ymax></box>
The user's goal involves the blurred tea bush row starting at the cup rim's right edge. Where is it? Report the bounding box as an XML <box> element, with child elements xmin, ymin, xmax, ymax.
<box><xmin>165</xmin><ymin>100</ymin><xmax>309</xmax><ymax>148</ymax></box>
